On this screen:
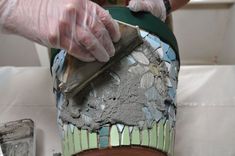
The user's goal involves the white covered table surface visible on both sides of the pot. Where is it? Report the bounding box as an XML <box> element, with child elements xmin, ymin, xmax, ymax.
<box><xmin>0</xmin><ymin>66</ymin><xmax>235</xmax><ymax>156</ymax></box>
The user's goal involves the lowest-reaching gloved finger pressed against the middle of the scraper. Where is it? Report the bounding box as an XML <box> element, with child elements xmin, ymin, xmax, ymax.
<box><xmin>76</xmin><ymin>26</ymin><xmax>109</xmax><ymax>62</ymax></box>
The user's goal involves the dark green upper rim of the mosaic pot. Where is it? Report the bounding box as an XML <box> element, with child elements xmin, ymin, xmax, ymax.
<box><xmin>105</xmin><ymin>6</ymin><xmax>180</xmax><ymax>61</ymax></box>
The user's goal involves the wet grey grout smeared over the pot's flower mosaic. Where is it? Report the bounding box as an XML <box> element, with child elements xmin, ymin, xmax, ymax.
<box><xmin>59</xmin><ymin>38</ymin><xmax>178</xmax><ymax>131</ymax></box>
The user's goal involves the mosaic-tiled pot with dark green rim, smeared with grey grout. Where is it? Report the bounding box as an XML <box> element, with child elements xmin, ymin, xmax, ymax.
<box><xmin>52</xmin><ymin>7</ymin><xmax>179</xmax><ymax>156</ymax></box>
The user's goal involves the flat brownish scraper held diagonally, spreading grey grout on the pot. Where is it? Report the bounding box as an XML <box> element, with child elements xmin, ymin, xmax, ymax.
<box><xmin>59</xmin><ymin>21</ymin><xmax>143</xmax><ymax>97</ymax></box>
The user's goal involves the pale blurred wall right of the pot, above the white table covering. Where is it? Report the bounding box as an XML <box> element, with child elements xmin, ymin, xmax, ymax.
<box><xmin>173</xmin><ymin>0</ymin><xmax>235</xmax><ymax>65</ymax></box>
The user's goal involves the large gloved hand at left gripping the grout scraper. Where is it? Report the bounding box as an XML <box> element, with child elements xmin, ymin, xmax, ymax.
<box><xmin>0</xmin><ymin>0</ymin><xmax>120</xmax><ymax>62</ymax></box>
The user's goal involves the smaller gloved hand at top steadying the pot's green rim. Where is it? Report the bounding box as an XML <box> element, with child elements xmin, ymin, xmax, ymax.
<box><xmin>127</xmin><ymin>0</ymin><xmax>166</xmax><ymax>21</ymax></box>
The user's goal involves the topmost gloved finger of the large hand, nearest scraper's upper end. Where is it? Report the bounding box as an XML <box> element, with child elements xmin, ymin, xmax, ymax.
<box><xmin>95</xmin><ymin>4</ymin><xmax>121</xmax><ymax>42</ymax></box>
